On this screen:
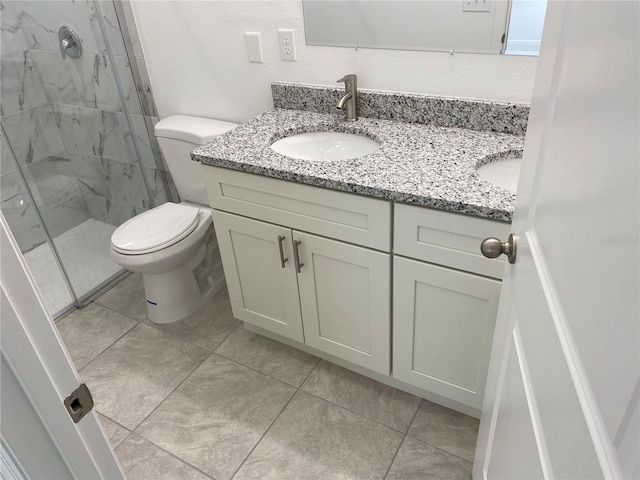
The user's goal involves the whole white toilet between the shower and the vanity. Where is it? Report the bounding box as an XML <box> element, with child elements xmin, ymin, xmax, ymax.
<box><xmin>111</xmin><ymin>115</ymin><xmax>237</xmax><ymax>324</ymax></box>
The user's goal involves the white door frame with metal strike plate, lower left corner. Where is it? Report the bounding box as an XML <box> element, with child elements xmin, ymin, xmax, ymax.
<box><xmin>0</xmin><ymin>214</ymin><xmax>124</xmax><ymax>479</ymax></box>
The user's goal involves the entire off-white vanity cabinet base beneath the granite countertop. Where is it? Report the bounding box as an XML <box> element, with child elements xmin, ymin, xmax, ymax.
<box><xmin>208</xmin><ymin>166</ymin><xmax>509</xmax><ymax>415</ymax></box>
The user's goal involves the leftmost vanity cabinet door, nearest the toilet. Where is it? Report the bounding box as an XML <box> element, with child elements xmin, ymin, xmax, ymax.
<box><xmin>213</xmin><ymin>210</ymin><xmax>304</xmax><ymax>342</ymax></box>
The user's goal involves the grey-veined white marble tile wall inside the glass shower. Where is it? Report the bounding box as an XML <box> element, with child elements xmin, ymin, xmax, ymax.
<box><xmin>0</xmin><ymin>0</ymin><xmax>171</xmax><ymax>255</ymax></box>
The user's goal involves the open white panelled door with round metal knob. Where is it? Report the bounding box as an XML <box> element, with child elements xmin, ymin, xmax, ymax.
<box><xmin>474</xmin><ymin>1</ymin><xmax>640</xmax><ymax>479</ymax></box>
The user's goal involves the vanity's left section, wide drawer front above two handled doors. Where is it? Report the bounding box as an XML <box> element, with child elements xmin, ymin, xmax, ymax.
<box><xmin>208</xmin><ymin>167</ymin><xmax>391</xmax><ymax>375</ymax></box>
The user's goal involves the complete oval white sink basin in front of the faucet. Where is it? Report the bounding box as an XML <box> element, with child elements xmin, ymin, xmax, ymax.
<box><xmin>271</xmin><ymin>132</ymin><xmax>380</xmax><ymax>162</ymax></box>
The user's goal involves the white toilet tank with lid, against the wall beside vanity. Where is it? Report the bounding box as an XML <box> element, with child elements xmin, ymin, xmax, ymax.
<box><xmin>155</xmin><ymin>115</ymin><xmax>238</xmax><ymax>205</ymax></box>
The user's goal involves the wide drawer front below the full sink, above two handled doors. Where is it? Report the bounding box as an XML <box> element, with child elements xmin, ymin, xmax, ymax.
<box><xmin>202</xmin><ymin>166</ymin><xmax>391</xmax><ymax>252</ymax></box>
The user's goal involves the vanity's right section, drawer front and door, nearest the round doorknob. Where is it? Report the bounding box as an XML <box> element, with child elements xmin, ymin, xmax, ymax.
<box><xmin>393</xmin><ymin>205</ymin><xmax>509</xmax><ymax>409</ymax></box>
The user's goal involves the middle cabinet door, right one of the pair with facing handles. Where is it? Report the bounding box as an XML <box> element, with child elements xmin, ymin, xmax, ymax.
<box><xmin>293</xmin><ymin>231</ymin><xmax>391</xmax><ymax>375</ymax></box>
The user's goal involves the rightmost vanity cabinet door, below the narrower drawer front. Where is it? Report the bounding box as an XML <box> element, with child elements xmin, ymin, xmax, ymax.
<box><xmin>393</xmin><ymin>257</ymin><xmax>501</xmax><ymax>409</ymax></box>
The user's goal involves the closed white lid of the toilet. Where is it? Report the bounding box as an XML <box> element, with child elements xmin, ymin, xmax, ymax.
<box><xmin>111</xmin><ymin>203</ymin><xmax>200</xmax><ymax>255</ymax></box>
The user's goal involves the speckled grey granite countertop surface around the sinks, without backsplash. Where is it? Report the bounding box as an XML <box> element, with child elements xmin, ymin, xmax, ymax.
<box><xmin>191</xmin><ymin>109</ymin><xmax>524</xmax><ymax>222</ymax></box>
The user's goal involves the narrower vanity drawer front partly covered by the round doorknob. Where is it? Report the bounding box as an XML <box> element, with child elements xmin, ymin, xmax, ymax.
<box><xmin>394</xmin><ymin>204</ymin><xmax>511</xmax><ymax>278</ymax></box>
